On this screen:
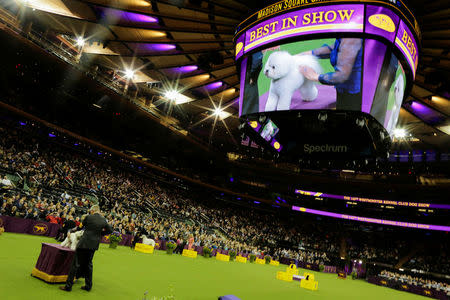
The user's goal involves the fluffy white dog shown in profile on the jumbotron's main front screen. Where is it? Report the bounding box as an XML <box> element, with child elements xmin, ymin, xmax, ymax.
<box><xmin>264</xmin><ymin>51</ymin><xmax>322</xmax><ymax>111</ymax></box>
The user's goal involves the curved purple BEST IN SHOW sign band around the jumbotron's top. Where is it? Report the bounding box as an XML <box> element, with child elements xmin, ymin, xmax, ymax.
<box><xmin>235</xmin><ymin>0</ymin><xmax>420</xmax><ymax>78</ymax></box>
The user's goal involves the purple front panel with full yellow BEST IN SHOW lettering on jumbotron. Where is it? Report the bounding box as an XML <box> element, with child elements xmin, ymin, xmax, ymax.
<box><xmin>244</xmin><ymin>4</ymin><xmax>364</xmax><ymax>53</ymax></box>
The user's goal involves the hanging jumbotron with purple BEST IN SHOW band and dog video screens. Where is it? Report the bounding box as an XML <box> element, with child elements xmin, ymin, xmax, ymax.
<box><xmin>235</xmin><ymin>1</ymin><xmax>420</xmax><ymax>137</ymax></box>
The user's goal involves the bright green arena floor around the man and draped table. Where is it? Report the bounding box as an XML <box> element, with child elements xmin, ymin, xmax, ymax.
<box><xmin>0</xmin><ymin>233</ymin><xmax>427</xmax><ymax>300</ymax></box>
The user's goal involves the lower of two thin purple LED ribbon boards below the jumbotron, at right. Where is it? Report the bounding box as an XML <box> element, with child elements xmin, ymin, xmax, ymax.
<box><xmin>292</xmin><ymin>206</ymin><xmax>450</xmax><ymax>232</ymax></box>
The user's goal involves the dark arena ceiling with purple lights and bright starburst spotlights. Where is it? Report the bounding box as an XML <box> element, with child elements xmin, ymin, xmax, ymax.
<box><xmin>2</xmin><ymin>0</ymin><xmax>450</xmax><ymax>149</ymax></box>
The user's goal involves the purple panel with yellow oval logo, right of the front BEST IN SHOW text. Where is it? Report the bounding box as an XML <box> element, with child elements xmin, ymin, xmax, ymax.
<box><xmin>365</xmin><ymin>5</ymin><xmax>400</xmax><ymax>42</ymax></box>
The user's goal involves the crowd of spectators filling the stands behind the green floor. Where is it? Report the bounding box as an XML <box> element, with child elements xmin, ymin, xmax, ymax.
<box><xmin>0</xmin><ymin>123</ymin><xmax>450</xmax><ymax>278</ymax></box>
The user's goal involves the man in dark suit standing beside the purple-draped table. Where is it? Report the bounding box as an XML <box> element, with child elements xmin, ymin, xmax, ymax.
<box><xmin>65</xmin><ymin>213</ymin><xmax>112</xmax><ymax>291</ymax></box>
